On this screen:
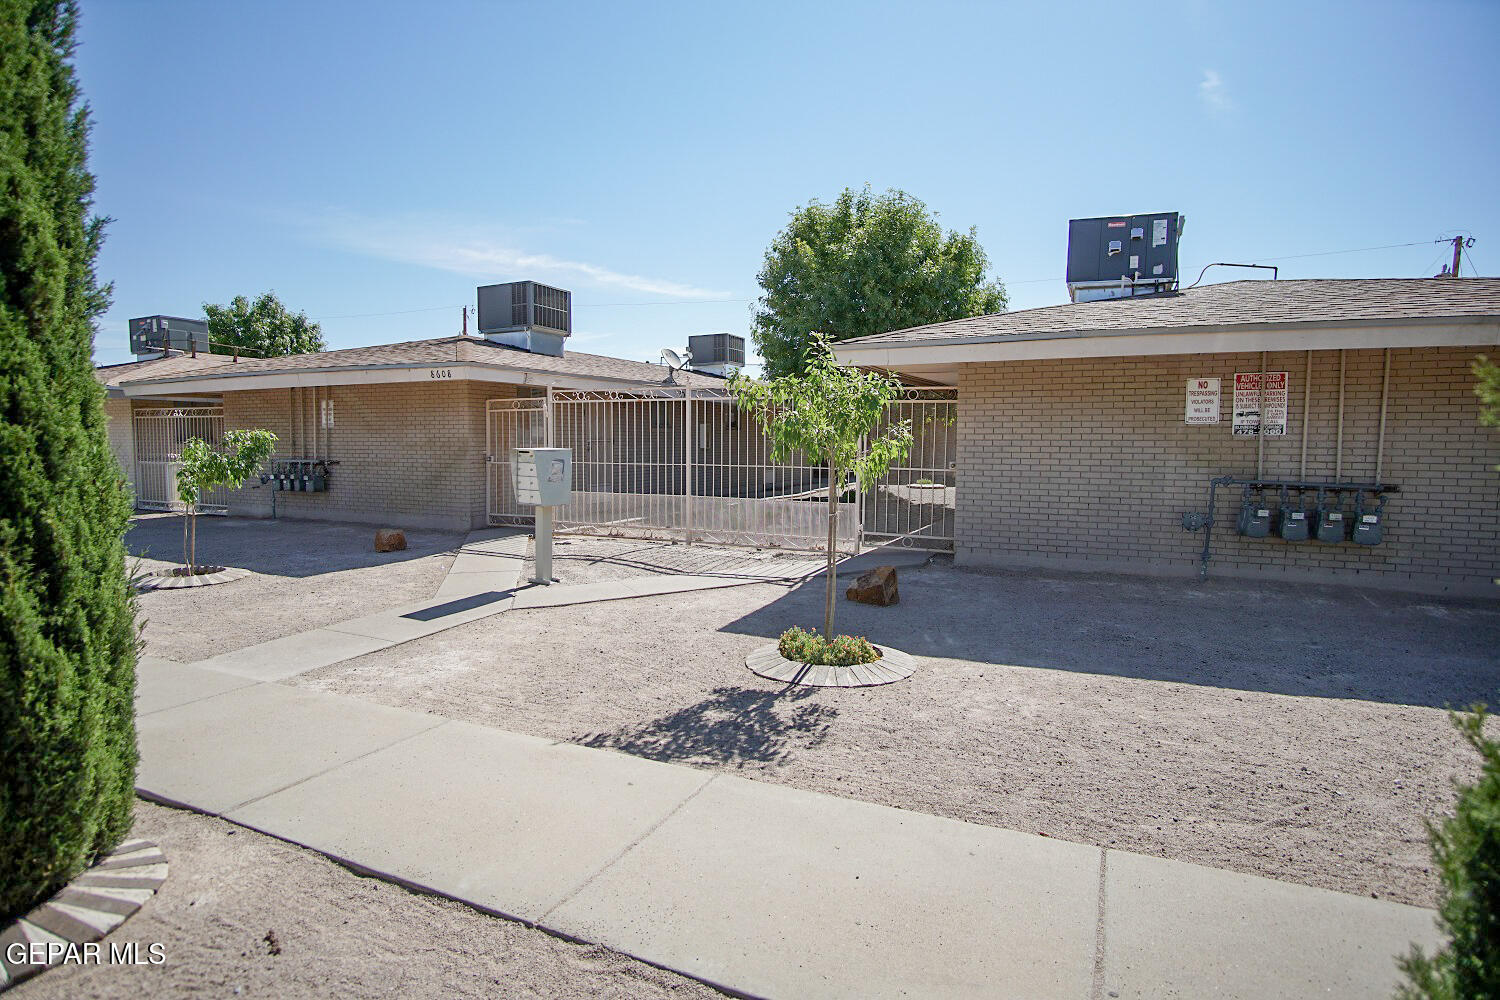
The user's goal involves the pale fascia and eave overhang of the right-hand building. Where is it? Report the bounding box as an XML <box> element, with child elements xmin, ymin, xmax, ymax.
<box><xmin>834</xmin><ymin>316</ymin><xmax>1500</xmax><ymax>385</ymax></box>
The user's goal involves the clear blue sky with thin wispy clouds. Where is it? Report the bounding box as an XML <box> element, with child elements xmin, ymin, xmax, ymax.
<box><xmin>78</xmin><ymin>0</ymin><xmax>1500</xmax><ymax>363</ymax></box>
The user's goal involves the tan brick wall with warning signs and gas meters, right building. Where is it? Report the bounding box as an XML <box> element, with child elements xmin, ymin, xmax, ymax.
<box><xmin>957</xmin><ymin>348</ymin><xmax>1500</xmax><ymax>595</ymax></box>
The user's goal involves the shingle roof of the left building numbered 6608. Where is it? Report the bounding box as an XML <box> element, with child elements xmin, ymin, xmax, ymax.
<box><xmin>98</xmin><ymin>337</ymin><xmax>723</xmax><ymax>385</ymax></box>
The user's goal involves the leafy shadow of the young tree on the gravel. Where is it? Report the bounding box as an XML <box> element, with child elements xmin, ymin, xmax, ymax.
<box><xmin>573</xmin><ymin>687</ymin><xmax>839</xmax><ymax>766</ymax></box>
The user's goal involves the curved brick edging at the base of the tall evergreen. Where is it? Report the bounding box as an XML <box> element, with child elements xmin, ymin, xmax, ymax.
<box><xmin>0</xmin><ymin>840</ymin><xmax>167</xmax><ymax>993</ymax></box>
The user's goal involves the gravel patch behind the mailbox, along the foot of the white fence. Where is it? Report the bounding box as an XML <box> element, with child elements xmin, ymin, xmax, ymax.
<box><xmin>521</xmin><ymin>535</ymin><xmax>818</xmax><ymax>583</ymax></box>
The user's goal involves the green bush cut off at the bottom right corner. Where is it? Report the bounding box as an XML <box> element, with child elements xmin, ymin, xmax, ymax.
<box><xmin>1397</xmin><ymin>705</ymin><xmax>1500</xmax><ymax>1000</ymax></box>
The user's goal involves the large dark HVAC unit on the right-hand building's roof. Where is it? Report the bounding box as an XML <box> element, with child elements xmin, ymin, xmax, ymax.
<box><xmin>1068</xmin><ymin>211</ymin><xmax>1185</xmax><ymax>301</ymax></box>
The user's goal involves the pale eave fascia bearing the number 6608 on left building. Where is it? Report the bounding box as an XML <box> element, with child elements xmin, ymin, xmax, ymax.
<box><xmin>120</xmin><ymin>361</ymin><xmax>687</xmax><ymax>399</ymax></box>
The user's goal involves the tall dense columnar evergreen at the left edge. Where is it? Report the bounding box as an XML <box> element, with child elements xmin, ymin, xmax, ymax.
<box><xmin>0</xmin><ymin>0</ymin><xmax>137</xmax><ymax>922</ymax></box>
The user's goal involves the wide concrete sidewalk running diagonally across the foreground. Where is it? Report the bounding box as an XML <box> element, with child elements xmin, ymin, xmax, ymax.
<box><xmin>138</xmin><ymin>657</ymin><xmax>1437</xmax><ymax>1000</ymax></box>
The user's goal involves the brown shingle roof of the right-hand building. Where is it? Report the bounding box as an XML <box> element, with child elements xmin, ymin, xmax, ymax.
<box><xmin>840</xmin><ymin>277</ymin><xmax>1500</xmax><ymax>348</ymax></box>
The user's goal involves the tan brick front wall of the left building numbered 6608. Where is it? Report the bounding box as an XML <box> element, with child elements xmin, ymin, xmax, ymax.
<box><xmin>224</xmin><ymin>381</ymin><xmax>515</xmax><ymax>529</ymax></box>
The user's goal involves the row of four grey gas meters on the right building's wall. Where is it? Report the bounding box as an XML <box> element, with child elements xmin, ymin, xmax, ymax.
<box><xmin>1236</xmin><ymin>483</ymin><xmax>1394</xmax><ymax>546</ymax></box>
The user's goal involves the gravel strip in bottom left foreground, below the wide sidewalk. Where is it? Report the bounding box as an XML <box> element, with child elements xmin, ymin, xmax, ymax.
<box><xmin>9</xmin><ymin>802</ymin><xmax>722</xmax><ymax>1000</ymax></box>
